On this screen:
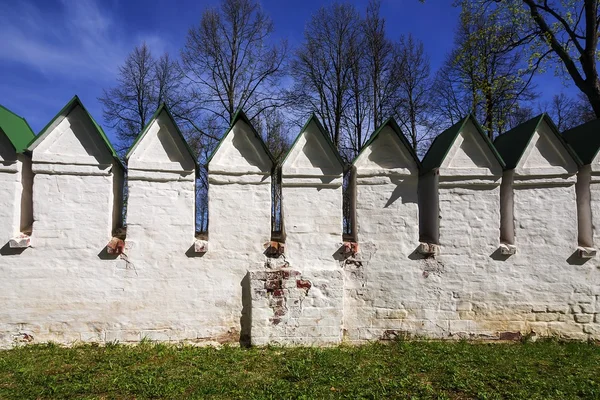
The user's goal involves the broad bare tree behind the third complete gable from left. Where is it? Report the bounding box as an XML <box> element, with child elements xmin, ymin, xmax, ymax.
<box><xmin>182</xmin><ymin>0</ymin><xmax>287</xmax><ymax>130</ymax></box>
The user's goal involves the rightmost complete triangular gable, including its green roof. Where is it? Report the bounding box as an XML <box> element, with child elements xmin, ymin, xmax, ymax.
<box><xmin>494</xmin><ymin>113</ymin><xmax>581</xmax><ymax>173</ymax></box>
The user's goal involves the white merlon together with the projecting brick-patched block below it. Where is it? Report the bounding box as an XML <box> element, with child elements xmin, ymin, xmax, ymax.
<box><xmin>250</xmin><ymin>118</ymin><xmax>344</xmax><ymax>344</ymax></box>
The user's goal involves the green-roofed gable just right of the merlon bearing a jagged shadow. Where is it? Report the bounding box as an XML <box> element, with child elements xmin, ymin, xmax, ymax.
<box><xmin>423</xmin><ymin>115</ymin><xmax>505</xmax><ymax>173</ymax></box>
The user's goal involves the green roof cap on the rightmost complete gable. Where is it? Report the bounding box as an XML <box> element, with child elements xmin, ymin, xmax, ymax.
<box><xmin>494</xmin><ymin>113</ymin><xmax>581</xmax><ymax>169</ymax></box>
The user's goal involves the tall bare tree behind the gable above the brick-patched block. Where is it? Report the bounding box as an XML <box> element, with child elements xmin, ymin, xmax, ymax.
<box><xmin>291</xmin><ymin>3</ymin><xmax>361</xmax><ymax>152</ymax></box>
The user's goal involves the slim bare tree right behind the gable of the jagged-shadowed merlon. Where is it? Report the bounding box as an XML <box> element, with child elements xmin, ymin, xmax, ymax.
<box><xmin>395</xmin><ymin>34</ymin><xmax>431</xmax><ymax>151</ymax></box>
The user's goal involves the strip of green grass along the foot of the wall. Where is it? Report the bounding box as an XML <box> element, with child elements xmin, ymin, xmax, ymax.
<box><xmin>0</xmin><ymin>341</ymin><xmax>600</xmax><ymax>399</ymax></box>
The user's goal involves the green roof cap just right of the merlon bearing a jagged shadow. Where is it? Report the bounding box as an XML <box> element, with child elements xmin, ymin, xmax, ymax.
<box><xmin>423</xmin><ymin>114</ymin><xmax>505</xmax><ymax>172</ymax></box>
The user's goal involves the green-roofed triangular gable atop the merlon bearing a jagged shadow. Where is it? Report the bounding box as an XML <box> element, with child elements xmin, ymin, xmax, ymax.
<box><xmin>352</xmin><ymin>118</ymin><xmax>421</xmax><ymax>172</ymax></box>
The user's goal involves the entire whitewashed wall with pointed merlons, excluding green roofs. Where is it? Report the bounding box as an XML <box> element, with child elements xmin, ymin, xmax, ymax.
<box><xmin>0</xmin><ymin>109</ymin><xmax>600</xmax><ymax>347</ymax></box>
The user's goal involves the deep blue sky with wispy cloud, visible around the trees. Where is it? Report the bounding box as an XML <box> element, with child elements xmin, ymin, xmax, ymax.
<box><xmin>0</xmin><ymin>0</ymin><xmax>572</xmax><ymax>144</ymax></box>
